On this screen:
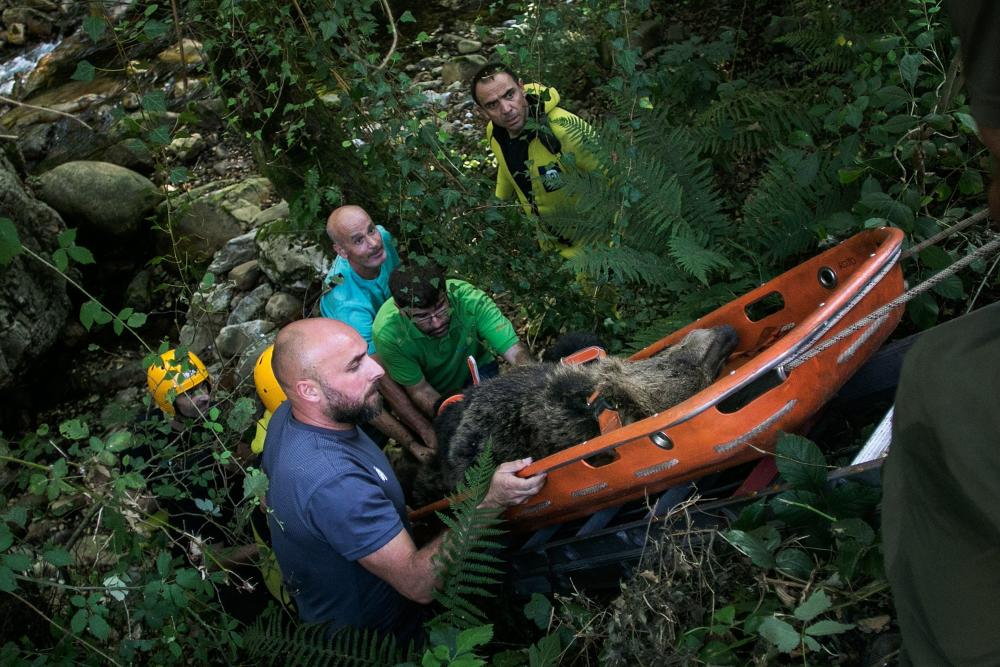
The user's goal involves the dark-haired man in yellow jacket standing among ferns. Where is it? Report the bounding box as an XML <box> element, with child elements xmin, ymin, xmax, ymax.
<box><xmin>471</xmin><ymin>63</ymin><xmax>597</xmax><ymax>254</ymax></box>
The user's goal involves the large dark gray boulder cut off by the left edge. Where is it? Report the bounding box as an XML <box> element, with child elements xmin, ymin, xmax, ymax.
<box><xmin>0</xmin><ymin>144</ymin><xmax>70</xmax><ymax>389</ymax></box>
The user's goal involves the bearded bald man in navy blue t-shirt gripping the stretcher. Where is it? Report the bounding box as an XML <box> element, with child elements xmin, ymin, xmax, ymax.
<box><xmin>263</xmin><ymin>318</ymin><xmax>545</xmax><ymax>642</ymax></box>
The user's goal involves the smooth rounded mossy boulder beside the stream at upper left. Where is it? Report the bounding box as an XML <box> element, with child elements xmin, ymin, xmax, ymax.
<box><xmin>38</xmin><ymin>161</ymin><xmax>163</xmax><ymax>236</ymax></box>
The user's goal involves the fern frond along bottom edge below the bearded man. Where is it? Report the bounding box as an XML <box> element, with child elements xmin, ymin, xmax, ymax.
<box><xmin>243</xmin><ymin>606</ymin><xmax>415</xmax><ymax>667</ymax></box>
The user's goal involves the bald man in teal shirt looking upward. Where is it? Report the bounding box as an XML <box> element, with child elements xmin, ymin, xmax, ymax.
<box><xmin>319</xmin><ymin>205</ymin><xmax>437</xmax><ymax>460</ymax></box>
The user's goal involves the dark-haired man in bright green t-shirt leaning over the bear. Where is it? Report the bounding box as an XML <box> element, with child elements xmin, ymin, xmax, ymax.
<box><xmin>374</xmin><ymin>264</ymin><xmax>532</xmax><ymax>416</ymax></box>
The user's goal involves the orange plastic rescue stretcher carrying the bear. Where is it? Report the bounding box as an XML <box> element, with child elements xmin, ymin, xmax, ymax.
<box><xmin>411</xmin><ymin>228</ymin><xmax>903</xmax><ymax>530</ymax></box>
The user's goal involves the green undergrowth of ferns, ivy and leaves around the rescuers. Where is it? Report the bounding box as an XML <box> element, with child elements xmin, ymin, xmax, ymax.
<box><xmin>0</xmin><ymin>0</ymin><xmax>996</xmax><ymax>665</ymax></box>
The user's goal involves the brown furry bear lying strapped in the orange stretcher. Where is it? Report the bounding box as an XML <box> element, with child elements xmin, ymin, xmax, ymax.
<box><xmin>413</xmin><ymin>326</ymin><xmax>737</xmax><ymax>506</ymax></box>
